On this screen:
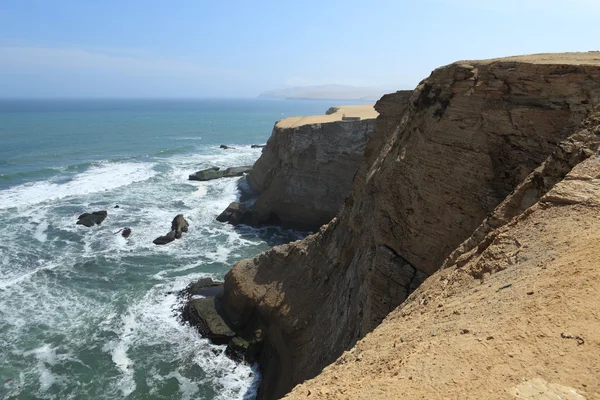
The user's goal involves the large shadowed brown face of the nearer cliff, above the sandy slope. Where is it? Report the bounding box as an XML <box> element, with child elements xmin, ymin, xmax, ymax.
<box><xmin>223</xmin><ymin>56</ymin><xmax>600</xmax><ymax>398</ymax></box>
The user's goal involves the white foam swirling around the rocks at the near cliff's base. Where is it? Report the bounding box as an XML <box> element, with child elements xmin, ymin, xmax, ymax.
<box><xmin>105</xmin><ymin>273</ymin><xmax>257</xmax><ymax>400</ymax></box>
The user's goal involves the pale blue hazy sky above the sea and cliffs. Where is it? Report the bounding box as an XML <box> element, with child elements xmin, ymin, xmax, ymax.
<box><xmin>0</xmin><ymin>0</ymin><xmax>600</xmax><ymax>98</ymax></box>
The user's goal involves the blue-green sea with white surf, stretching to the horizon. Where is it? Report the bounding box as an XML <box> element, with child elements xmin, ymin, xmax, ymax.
<box><xmin>0</xmin><ymin>99</ymin><xmax>350</xmax><ymax>400</ymax></box>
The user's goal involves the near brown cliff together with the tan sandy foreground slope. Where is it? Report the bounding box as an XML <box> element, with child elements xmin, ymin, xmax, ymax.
<box><xmin>223</xmin><ymin>53</ymin><xmax>600</xmax><ymax>399</ymax></box>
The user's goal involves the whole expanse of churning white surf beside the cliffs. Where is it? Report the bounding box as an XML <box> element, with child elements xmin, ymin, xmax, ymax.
<box><xmin>0</xmin><ymin>145</ymin><xmax>294</xmax><ymax>400</ymax></box>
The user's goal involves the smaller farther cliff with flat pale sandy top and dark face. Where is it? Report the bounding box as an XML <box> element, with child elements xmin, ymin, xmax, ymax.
<box><xmin>238</xmin><ymin>105</ymin><xmax>377</xmax><ymax>231</ymax></box>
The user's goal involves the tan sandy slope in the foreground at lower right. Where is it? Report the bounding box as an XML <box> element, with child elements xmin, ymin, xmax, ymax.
<box><xmin>286</xmin><ymin>105</ymin><xmax>600</xmax><ymax>400</ymax></box>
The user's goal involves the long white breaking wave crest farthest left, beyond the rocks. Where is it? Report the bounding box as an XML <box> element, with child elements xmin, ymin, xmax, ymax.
<box><xmin>0</xmin><ymin>162</ymin><xmax>156</xmax><ymax>209</ymax></box>
